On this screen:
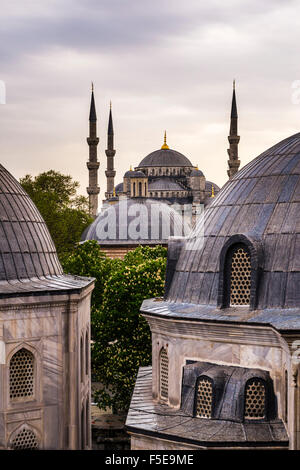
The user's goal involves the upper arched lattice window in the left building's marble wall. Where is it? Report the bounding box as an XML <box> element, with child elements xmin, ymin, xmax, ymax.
<box><xmin>9</xmin><ymin>348</ymin><xmax>34</xmax><ymax>400</ymax></box>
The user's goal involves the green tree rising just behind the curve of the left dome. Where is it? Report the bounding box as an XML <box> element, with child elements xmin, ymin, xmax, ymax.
<box><xmin>20</xmin><ymin>170</ymin><xmax>92</xmax><ymax>260</ymax></box>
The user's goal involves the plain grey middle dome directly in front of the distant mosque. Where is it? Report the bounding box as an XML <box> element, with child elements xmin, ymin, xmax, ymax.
<box><xmin>81</xmin><ymin>198</ymin><xmax>189</xmax><ymax>245</ymax></box>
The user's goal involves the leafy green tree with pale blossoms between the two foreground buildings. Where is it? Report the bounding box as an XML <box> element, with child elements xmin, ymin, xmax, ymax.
<box><xmin>64</xmin><ymin>241</ymin><xmax>167</xmax><ymax>412</ymax></box>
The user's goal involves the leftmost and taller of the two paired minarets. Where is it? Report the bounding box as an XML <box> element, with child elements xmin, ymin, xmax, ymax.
<box><xmin>86</xmin><ymin>84</ymin><xmax>100</xmax><ymax>218</ymax></box>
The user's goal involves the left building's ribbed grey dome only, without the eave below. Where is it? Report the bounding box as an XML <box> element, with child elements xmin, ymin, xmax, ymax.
<box><xmin>0</xmin><ymin>165</ymin><xmax>62</xmax><ymax>281</ymax></box>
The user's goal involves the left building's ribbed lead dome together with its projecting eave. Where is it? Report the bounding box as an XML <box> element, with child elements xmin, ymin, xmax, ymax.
<box><xmin>0</xmin><ymin>165</ymin><xmax>92</xmax><ymax>295</ymax></box>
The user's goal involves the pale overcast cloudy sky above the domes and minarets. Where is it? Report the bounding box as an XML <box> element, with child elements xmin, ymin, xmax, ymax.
<box><xmin>0</xmin><ymin>0</ymin><xmax>300</xmax><ymax>197</ymax></box>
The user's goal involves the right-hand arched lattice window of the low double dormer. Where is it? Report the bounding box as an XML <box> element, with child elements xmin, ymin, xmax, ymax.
<box><xmin>244</xmin><ymin>378</ymin><xmax>266</xmax><ymax>419</ymax></box>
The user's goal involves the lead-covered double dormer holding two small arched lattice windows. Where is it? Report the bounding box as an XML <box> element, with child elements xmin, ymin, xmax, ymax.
<box><xmin>181</xmin><ymin>361</ymin><xmax>277</xmax><ymax>423</ymax></box>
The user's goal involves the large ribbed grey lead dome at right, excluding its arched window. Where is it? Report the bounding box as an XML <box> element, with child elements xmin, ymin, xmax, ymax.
<box><xmin>168</xmin><ymin>133</ymin><xmax>300</xmax><ymax>314</ymax></box>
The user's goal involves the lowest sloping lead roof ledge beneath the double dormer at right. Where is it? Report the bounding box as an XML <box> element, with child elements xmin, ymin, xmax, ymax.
<box><xmin>126</xmin><ymin>367</ymin><xmax>288</xmax><ymax>448</ymax></box>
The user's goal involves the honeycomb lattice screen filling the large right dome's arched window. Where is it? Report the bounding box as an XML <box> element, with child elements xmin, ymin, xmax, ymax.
<box><xmin>230</xmin><ymin>247</ymin><xmax>251</xmax><ymax>305</ymax></box>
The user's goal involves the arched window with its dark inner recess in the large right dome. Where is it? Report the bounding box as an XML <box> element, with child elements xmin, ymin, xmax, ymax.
<box><xmin>225</xmin><ymin>244</ymin><xmax>251</xmax><ymax>306</ymax></box>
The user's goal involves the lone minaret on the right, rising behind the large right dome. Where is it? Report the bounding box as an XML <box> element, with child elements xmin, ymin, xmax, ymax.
<box><xmin>227</xmin><ymin>80</ymin><xmax>241</xmax><ymax>178</ymax></box>
